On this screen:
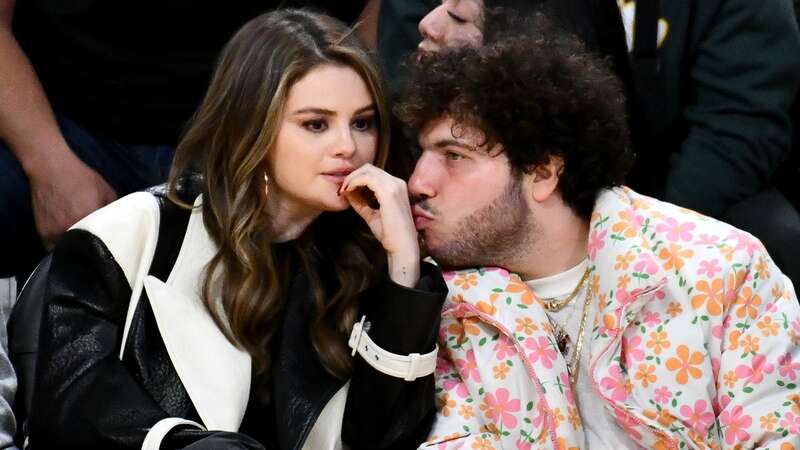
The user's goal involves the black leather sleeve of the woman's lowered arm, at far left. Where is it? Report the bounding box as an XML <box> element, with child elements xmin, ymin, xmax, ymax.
<box><xmin>30</xmin><ymin>230</ymin><xmax>266</xmax><ymax>450</ymax></box>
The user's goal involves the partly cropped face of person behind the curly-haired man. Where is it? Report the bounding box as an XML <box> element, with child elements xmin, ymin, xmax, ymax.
<box><xmin>419</xmin><ymin>0</ymin><xmax>483</xmax><ymax>54</ymax></box>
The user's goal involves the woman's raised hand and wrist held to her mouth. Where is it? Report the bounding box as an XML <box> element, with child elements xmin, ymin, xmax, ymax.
<box><xmin>339</xmin><ymin>164</ymin><xmax>419</xmax><ymax>287</ymax></box>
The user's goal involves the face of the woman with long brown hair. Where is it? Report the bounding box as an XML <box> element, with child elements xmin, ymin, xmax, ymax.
<box><xmin>267</xmin><ymin>64</ymin><xmax>379</xmax><ymax>213</ymax></box>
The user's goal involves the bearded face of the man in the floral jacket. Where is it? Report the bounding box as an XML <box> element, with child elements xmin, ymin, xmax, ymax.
<box><xmin>408</xmin><ymin>117</ymin><xmax>535</xmax><ymax>268</ymax></box>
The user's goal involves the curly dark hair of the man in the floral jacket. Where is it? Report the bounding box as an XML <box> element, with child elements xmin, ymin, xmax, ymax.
<box><xmin>396</xmin><ymin>14</ymin><xmax>633</xmax><ymax>218</ymax></box>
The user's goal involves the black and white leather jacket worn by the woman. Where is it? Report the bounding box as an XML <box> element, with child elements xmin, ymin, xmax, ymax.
<box><xmin>26</xmin><ymin>192</ymin><xmax>446</xmax><ymax>450</ymax></box>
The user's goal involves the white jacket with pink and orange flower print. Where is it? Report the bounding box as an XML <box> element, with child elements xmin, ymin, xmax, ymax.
<box><xmin>420</xmin><ymin>188</ymin><xmax>800</xmax><ymax>450</ymax></box>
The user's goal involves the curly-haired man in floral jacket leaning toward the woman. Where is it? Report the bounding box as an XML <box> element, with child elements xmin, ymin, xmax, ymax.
<box><xmin>400</xmin><ymin>22</ymin><xmax>800</xmax><ymax>449</ymax></box>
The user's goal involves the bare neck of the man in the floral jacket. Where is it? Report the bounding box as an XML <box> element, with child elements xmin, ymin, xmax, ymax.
<box><xmin>508</xmin><ymin>203</ymin><xmax>589</xmax><ymax>280</ymax></box>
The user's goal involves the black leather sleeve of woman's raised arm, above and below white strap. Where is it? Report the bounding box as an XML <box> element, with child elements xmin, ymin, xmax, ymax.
<box><xmin>342</xmin><ymin>263</ymin><xmax>447</xmax><ymax>450</ymax></box>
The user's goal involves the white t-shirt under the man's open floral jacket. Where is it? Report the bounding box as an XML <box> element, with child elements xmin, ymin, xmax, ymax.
<box><xmin>526</xmin><ymin>259</ymin><xmax>639</xmax><ymax>450</ymax></box>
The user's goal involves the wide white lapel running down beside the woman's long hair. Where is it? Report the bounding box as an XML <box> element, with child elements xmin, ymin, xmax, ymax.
<box><xmin>144</xmin><ymin>197</ymin><xmax>251</xmax><ymax>431</ymax></box>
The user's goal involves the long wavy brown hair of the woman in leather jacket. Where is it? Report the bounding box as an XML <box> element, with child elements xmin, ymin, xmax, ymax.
<box><xmin>169</xmin><ymin>9</ymin><xmax>389</xmax><ymax>378</ymax></box>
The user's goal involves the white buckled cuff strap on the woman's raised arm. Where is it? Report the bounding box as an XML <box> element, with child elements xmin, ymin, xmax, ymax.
<box><xmin>347</xmin><ymin>316</ymin><xmax>439</xmax><ymax>381</ymax></box>
